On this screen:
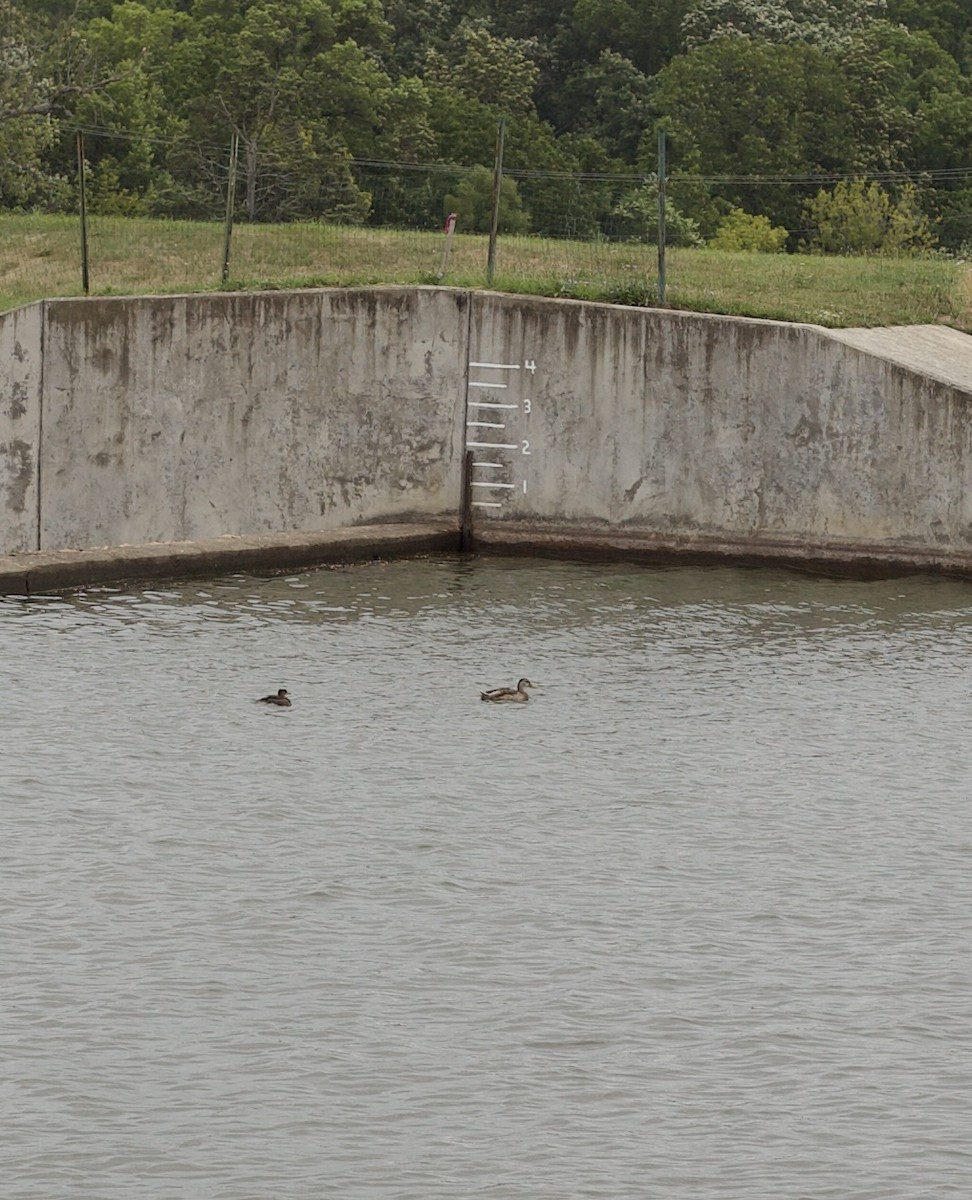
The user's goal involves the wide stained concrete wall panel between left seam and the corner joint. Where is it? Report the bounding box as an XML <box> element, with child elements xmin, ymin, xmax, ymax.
<box><xmin>38</xmin><ymin>289</ymin><xmax>468</xmax><ymax>550</ymax></box>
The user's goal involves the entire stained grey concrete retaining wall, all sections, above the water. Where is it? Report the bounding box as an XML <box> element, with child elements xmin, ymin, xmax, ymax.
<box><xmin>0</xmin><ymin>288</ymin><xmax>972</xmax><ymax>571</ymax></box>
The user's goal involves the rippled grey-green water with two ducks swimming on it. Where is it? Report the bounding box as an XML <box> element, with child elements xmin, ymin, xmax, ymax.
<box><xmin>0</xmin><ymin>560</ymin><xmax>972</xmax><ymax>1200</ymax></box>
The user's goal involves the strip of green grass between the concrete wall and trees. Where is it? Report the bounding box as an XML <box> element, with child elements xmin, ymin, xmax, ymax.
<box><xmin>0</xmin><ymin>215</ymin><xmax>972</xmax><ymax>332</ymax></box>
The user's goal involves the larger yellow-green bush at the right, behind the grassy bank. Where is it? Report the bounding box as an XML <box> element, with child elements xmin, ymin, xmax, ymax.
<box><xmin>806</xmin><ymin>179</ymin><xmax>935</xmax><ymax>258</ymax></box>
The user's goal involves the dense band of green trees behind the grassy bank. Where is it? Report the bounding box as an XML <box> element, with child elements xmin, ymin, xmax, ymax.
<box><xmin>0</xmin><ymin>0</ymin><xmax>972</xmax><ymax>251</ymax></box>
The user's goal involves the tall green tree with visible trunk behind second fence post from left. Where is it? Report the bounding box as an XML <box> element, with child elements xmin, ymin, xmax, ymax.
<box><xmin>170</xmin><ymin>0</ymin><xmax>392</xmax><ymax>220</ymax></box>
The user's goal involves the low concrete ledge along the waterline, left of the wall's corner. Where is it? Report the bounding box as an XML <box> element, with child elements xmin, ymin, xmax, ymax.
<box><xmin>0</xmin><ymin>524</ymin><xmax>460</xmax><ymax>595</ymax></box>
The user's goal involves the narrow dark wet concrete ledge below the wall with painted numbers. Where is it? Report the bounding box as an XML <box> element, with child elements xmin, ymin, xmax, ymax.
<box><xmin>473</xmin><ymin>521</ymin><xmax>972</xmax><ymax>578</ymax></box>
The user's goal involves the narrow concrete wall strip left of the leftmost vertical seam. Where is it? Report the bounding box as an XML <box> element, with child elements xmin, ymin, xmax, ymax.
<box><xmin>0</xmin><ymin>305</ymin><xmax>43</xmax><ymax>553</ymax></box>
